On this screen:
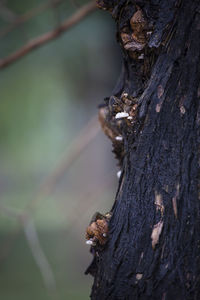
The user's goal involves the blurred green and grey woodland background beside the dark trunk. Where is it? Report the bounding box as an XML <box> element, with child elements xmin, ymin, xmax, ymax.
<box><xmin>0</xmin><ymin>0</ymin><xmax>121</xmax><ymax>300</ymax></box>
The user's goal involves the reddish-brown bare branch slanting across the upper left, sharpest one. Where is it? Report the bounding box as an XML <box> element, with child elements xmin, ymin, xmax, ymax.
<box><xmin>0</xmin><ymin>1</ymin><xmax>96</xmax><ymax>69</ymax></box>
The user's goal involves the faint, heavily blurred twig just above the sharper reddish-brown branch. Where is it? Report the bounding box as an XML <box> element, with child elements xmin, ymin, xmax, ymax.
<box><xmin>0</xmin><ymin>0</ymin><xmax>63</xmax><ymax>38</ymax></box>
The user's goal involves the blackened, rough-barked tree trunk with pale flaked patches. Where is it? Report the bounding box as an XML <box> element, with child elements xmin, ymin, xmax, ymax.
<box><xmin>87</xmin><ymin>0</ymin><xmax>200</xmax><ymax>300</ymax></box>
